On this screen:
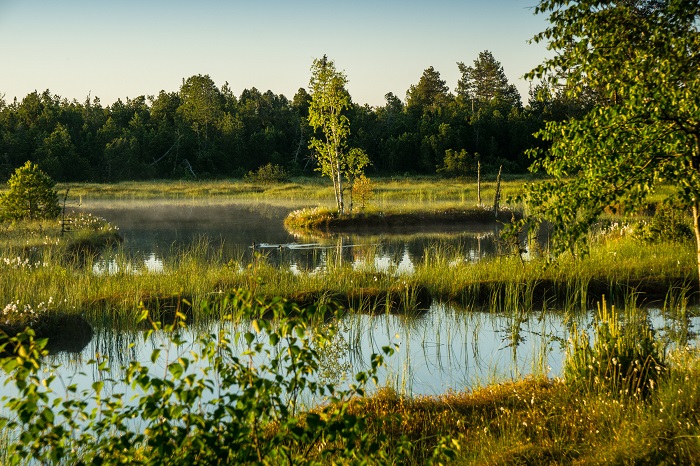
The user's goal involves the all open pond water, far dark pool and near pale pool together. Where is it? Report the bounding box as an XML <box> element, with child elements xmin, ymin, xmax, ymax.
<box><xmin>0</xmin><ymin>200</ymin><xmax>698</xmax><ymax>404</ymax></box>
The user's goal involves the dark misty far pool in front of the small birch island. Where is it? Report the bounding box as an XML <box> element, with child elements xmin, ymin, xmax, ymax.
<box><xmin>80</xmin><ymin>200</ymin><xmax>499</xmax><ymax>272</ymax></box>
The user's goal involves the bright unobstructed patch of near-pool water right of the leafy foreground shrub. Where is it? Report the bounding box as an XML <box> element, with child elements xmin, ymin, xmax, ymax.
<box><xmin>348</xmin><ymin>305</ymin><xmax>565</xmax><ymax>394</ymax></box>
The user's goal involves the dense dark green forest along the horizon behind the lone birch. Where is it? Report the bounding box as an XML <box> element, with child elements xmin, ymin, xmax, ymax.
<box><xmin>0</xmin><ymin>51</ymin><xmax>586</xmax><ymax>182</ymax></box>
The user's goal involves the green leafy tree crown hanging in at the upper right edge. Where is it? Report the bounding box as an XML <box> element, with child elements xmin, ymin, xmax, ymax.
<box><xmin>525</xmin><ymin>0</ymin><xmax>700</xmax><ymax>284</ymax></box>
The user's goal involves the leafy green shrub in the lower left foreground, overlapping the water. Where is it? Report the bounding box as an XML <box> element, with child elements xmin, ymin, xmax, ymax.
<box><xmin>0</xmin><ymin>291</ymin><xmax>452</xmax><ymax>465</ymax></box>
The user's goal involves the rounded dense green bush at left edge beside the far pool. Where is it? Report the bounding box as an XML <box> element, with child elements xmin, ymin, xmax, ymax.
<box><xmin>0</xmin><ymin>161</ymin><xmax>61</xmax><ymax>220</ymax></box>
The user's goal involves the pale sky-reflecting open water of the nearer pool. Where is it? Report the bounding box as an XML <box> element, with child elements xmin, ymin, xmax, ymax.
<box><xmin>0</xmin><ymin>304</ymin><xmax>700</xmax><ymax>412</ymax></box>
